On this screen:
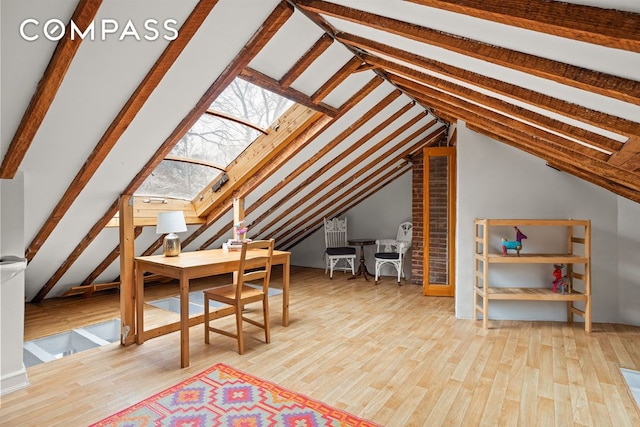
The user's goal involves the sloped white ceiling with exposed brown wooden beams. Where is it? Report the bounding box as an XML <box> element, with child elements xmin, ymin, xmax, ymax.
<box><xmin>0</xmin><ymin>0</ymin><xmax>640</xmax><ymax>302</ymax></box>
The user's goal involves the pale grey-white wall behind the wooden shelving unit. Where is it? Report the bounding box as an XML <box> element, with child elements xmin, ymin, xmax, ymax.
<box><xmin>456</xmin><ymin>124</ymin><xmax>640</xmax><ymax>324</ymax></box>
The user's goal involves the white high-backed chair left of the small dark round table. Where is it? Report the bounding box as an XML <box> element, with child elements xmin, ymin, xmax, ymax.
<box><xmin>324</xmin><ymin>217</ymin><xmax>356</xmax><ymax>279</ymax></box>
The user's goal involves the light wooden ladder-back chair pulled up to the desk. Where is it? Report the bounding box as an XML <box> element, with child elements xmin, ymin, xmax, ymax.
<box><xmin>203</xmin><ymin>239</ymin><xmax>274</xmax><ymax>354</ymax></box>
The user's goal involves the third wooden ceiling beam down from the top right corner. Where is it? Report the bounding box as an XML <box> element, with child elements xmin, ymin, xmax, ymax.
<box><xmin>336</xmin><ymin>33</ymin><xmax>640</xmax><ymax>136</ymax></box>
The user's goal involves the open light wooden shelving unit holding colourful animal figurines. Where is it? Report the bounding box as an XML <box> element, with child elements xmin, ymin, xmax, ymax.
<box><xmin>474</xmin><ymin>219</ymin><xmax>591</xmax><ymax>332</ymax></box>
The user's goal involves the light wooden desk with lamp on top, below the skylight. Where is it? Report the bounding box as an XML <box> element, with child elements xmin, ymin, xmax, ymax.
<box><xmin>134</xmin><ymin>249</ymin><xmax>291</xmax><ymax>368</ymax></box>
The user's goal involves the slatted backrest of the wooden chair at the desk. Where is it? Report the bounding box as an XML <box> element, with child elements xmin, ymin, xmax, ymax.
<box><xmin>236</xmin><ymin>239</ymin><xmax>274</xmax><ymax>298</ymax></box>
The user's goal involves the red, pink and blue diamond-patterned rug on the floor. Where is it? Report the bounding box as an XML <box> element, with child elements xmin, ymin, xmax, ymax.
<box><xmin>91</xmin><ymin>363</ymin><xmax>377</xmax><ymax>427</ymax></box>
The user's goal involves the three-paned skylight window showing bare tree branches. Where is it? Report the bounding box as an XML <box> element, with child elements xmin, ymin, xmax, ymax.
<box><xmin>135</xmin><ymin>78</ymin><xmax>293</xmax><ymax>200</ymax></box>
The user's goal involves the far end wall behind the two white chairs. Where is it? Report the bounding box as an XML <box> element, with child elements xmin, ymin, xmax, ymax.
<box><xmin>291</xmin><ymin>172</ymin><xmax>411</xmax><ymax>278</ymax></box>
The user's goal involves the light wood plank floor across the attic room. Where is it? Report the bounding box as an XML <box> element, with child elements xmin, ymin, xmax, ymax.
<box><xmin>0</xmin><ymin>268</ymin><xmax>640</xmax><ymax>427</ymax></box>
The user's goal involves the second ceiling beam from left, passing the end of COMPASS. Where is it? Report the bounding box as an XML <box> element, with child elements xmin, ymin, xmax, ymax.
<box><xmin>25</xmin><ymin>0</ymin><xmax>218</xmax><ymax>261</ymax></box>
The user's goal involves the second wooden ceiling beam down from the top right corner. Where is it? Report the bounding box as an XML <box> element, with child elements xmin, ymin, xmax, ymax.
<box><xmin>295</xmin><ymin>0</ymin><xmax>640</xmax><ymax>105</ymax></box>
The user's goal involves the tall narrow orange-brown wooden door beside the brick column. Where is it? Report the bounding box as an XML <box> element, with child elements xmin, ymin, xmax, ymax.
<box><xmin>422</xmin><ymin>147</ymin><xmax>456</xmax><ymax>296</ymax></box>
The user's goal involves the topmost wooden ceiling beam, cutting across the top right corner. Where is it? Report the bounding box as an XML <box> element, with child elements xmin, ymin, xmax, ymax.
<box><xmin>407</xmin><ymin>0</ymin><xmax>640</xmax><ymax>52</ymax></box>
